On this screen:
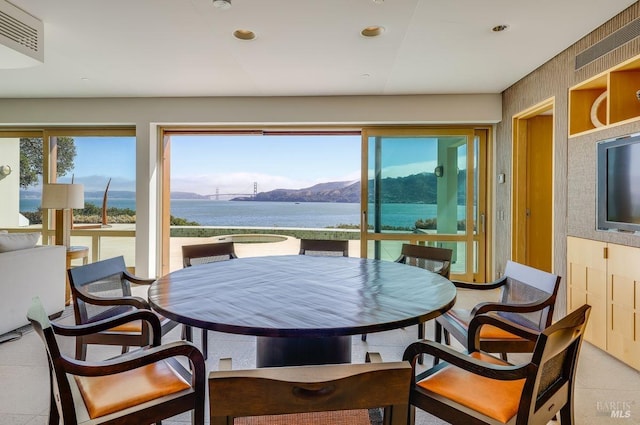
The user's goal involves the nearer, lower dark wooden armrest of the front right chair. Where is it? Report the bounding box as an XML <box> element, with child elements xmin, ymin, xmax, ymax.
<box><xmin>402</xmin><ymin>340</ymin><xmax>529</xmax><ymax>383</ymax></box>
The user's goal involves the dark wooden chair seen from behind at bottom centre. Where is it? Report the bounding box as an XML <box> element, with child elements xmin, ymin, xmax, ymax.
<box><xmin>209</xmin><ymin>359</ymin><xmax>411</xmax><ymax>425</ymax></box>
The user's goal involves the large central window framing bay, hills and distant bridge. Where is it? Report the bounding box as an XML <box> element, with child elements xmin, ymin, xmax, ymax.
<box><xmin>169</xmin><ymin>132</ymin><xmax>361</xmax><ymax>269</ymax></box>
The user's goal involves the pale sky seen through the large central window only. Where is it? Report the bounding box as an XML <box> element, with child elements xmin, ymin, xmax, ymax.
<box><xmin>171</xmin><ymin>135</ymin><xmax>360</xmax><ymax>195</ymax></box>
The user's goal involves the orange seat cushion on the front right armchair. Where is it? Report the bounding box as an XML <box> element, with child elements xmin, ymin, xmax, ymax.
<box><xmin>417</xmin><ymin>352</ymin><xmax>525</xmax><ymax>423</ymax></box>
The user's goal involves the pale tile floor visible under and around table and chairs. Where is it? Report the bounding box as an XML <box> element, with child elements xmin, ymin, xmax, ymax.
<box><xmin>0</xmin><ymin>297</ymin><xmax>640</xmax><ymax>425</ymax></box>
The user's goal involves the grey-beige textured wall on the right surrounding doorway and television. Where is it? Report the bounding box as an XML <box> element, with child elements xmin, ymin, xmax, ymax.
<box><xmin>495</xmin><ymin>2</ymin><xmax>640</xmax><ymax>314</ymax></box>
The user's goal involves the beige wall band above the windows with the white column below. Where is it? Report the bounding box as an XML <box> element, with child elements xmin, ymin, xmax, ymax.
<box><xmin>0</xmin><ymin>94</ymin><xmax>502</xmax><ymax>276</ymax></box>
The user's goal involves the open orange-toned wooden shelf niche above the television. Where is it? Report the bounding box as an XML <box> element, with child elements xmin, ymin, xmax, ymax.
<box><xmin>569</xmin><ymin>56</ymin><xmax>640</xmax><ymax>136</ymax></box>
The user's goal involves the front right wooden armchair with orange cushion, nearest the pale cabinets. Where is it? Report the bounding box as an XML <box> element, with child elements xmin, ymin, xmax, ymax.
<box><xmin>404</xmin><ymin>305</ymin><xmax>591</xmax><ymax>425</ymax></box>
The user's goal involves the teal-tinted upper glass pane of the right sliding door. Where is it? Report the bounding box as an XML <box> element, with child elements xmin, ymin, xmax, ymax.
<box><xmin>368</xmin><ymin>136</ymin><xmax>467</xmax><ymax>234</ymax></box>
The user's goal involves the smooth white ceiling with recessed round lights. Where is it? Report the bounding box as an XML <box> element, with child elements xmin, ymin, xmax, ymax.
<box><xmin>0</xmin><ymin>0</ymin><xmax>634</xmax><ymax>98</ymax></box>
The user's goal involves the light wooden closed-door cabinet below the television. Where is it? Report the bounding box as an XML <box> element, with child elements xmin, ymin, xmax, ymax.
<box><xmin>567</xmin><ymin>237</ymin><xmax>640</xmax><ymax>370</ymax></box>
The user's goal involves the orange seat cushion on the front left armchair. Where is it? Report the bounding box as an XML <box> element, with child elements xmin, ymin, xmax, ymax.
<box><xmin>75</xmin><ymin>361</ymin><xmax>191</xmax><ymax>419</ymax></box>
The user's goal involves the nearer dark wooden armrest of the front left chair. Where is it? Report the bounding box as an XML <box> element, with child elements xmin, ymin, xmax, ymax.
<box><xmin>62</xmin><ymin>341</ymin><xmax>205</xmax><ymax>387</ymax></box>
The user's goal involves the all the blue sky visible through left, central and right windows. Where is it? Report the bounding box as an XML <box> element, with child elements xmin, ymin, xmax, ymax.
<box><xmin>53</xmin><ymin>135</ymin><xmax>456</xmax><ymax>195</ymax></box>
